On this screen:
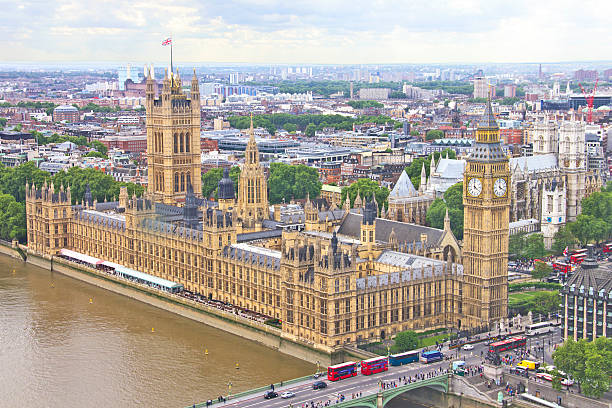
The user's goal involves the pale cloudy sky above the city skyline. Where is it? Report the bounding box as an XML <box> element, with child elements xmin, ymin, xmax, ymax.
<box><xmin>0</xmin><ymin>0</ymin><xmax>612</xmax><ymax>64</ymax></box>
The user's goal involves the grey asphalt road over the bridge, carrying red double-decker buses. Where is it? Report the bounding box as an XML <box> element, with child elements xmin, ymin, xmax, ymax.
<box><xmin>206</xmin><ymin>328</ymin><xmax>561</xmax><ymax>408</ymax></box>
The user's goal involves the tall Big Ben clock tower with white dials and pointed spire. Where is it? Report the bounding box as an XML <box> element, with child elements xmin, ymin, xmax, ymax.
<box><xmin>462</xmin><ymin>100</ymin><xmax>510</xmax><ymax>327</ymax></box>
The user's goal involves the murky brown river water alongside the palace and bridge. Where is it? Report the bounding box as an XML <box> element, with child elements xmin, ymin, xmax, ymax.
<box><xmin>0</xmin><ymin>255</ymin><xmax>474</xmax><ymax>408</ymax></box>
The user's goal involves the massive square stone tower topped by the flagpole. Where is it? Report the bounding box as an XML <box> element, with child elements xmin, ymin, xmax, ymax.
<box><xmin>146</xmin><ymin>70</ymin><xmax>202</xmax><ymax>204</ymax></box>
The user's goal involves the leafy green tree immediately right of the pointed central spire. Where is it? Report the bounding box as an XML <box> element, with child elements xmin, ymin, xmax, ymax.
<box><xmin>268</xmin><ymin>163</ymin><xmax>322</xmax><ymax>204</ymax></box>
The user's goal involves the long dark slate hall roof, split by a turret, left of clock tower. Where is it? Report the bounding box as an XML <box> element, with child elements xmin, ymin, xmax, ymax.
<box><xmin>338</xmin><ymin>212</ymin><xmax>444</xmax><ymax>247</ymax></box>
